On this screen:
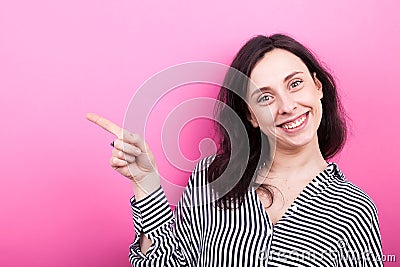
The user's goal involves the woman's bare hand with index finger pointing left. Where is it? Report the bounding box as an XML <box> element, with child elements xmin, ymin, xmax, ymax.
<box><xmin>86</xmin><ymin>113</ymin><xmax>160</xmax><ymax>197</ymax></box>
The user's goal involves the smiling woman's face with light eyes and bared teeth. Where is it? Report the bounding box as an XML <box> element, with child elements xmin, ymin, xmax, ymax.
<box><xmin>247</xmin><ymin>49</ymin><xmax>322</xmax><ymax>150</ymax></box>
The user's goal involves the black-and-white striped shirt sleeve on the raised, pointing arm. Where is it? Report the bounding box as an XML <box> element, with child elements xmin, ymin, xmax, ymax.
<box><xmin>129</xmin><ymin>168</ymin><xmax>203</xmax><ymax>267</ymax></box>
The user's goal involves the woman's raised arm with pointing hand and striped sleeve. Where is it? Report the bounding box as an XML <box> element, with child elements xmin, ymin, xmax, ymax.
<box><xmin>87</xmin><ymin>113</ymin><xmax>200</xmax><ymax>267</ymax></box>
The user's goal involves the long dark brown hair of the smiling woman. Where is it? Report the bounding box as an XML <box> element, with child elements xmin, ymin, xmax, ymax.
<box><xmin>207</xmin><ymin>34</ymin><xmax>347</xmax><ymax>208</ymax></box>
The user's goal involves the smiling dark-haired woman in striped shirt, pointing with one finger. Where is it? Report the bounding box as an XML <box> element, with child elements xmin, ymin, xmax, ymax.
<box><xmin>88</xmin><ymin>34</ymin><xmax>382</xmax><ymax>266</ymax></box>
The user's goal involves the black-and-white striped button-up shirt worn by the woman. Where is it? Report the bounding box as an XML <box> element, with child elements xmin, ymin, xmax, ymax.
<box><xmin>129</xmin><ymin>158</ymin><xmax>383</xmax><ymax>267</ymax></box>
